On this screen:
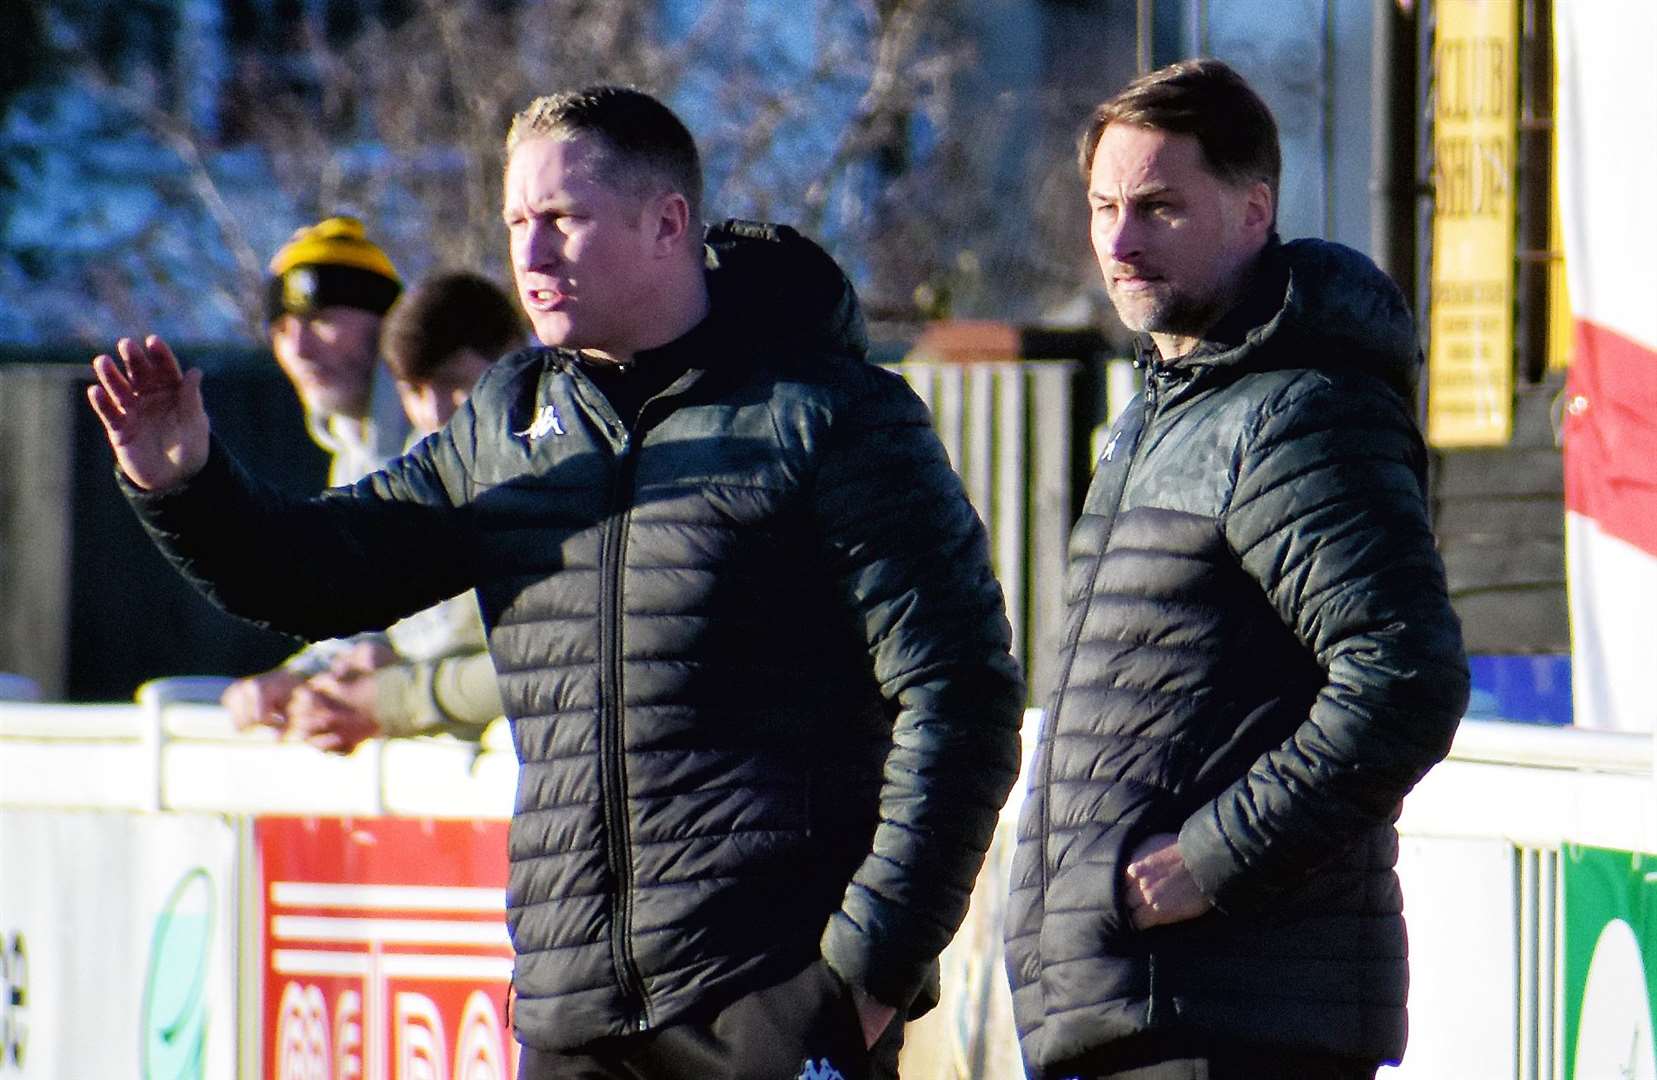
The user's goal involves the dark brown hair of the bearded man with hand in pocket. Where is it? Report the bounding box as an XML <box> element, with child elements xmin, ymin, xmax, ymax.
<box><xmin>1079</xmin><ymin>58</ymin><xmax>1283</xmax><ymax>212</ymax></box>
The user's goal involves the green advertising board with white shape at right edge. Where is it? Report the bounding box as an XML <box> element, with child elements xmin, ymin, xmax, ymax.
<box><xmin>1561</xmin><ymin>845</ymin><xmax>1657</xmax><ymax>1080</ymax></box>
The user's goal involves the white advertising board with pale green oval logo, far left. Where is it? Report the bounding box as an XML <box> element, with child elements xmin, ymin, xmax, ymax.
<box><xmin>0</xmin><ymin>810</ymin><xmax>237</xmax><ymax>1080</ymax></box>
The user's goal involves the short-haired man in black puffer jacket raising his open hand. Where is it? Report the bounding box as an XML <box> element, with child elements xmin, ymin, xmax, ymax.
<box><xmin>91</xmin><ymin>88</ymin><xmax>1024</xmax><ymax>1080</ymax></box>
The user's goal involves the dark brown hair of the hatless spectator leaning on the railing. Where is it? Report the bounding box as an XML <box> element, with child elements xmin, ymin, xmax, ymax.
<box><xmin>379</xmin><ymin>272</ymin><xmax>525</xmax><ymax>383</ymax></box>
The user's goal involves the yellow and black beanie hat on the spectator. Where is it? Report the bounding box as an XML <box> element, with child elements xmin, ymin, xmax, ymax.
<box><xmin>265</xmin><ymin>217</ymin><xmax>403</xmax><ymax>321</ymax></box>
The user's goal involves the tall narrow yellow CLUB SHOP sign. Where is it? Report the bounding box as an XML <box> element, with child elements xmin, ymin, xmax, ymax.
<box><xmin>1427</xmin><ymin>0</ymin><xmax>1518</xmax><ymax>446</ymax></box>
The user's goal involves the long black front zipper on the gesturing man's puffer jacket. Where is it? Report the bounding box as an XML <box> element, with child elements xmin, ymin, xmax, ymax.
<box><xmin>598</xmin><ymin>436</ymin><xmax>650</xmax><ymax>1032</ymax></box>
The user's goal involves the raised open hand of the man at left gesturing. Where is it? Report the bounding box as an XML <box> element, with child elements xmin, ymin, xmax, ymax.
<box><xmin>86</xmin><ymin>335</ymin><xmax>209</xmax><ymax>490</ymax></box>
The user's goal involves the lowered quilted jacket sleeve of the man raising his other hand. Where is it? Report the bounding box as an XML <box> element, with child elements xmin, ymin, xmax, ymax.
<box><xmin>812</xmin><ymin>368</ymin><xmax>1024</xmax><ymax>1009</ymax></box>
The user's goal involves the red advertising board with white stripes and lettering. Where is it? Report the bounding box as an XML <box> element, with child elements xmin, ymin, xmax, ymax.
<box><xmin>254</xmin><ymin>817</ymin><xmax>517</xmax><ymax>1080</ymax></box>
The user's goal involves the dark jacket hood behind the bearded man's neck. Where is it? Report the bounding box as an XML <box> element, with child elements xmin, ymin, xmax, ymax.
<box><xmin>1190</xmin><ymin>240</ymin><xmax>1422</xmax><ymax>399</ymax></box>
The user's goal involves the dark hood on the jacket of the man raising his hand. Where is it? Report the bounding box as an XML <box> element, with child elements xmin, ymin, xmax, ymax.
<box><xmin>704</xmin><ymin>219</ymin><xmax>868</xmax><ymax>358</ymax></box>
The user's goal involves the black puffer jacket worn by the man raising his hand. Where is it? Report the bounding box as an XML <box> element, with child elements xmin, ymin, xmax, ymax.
<box><xmin>136</xmin><ymin>225</ymin><xmax>1024</xmax><ymax>1049</ymax></box>
